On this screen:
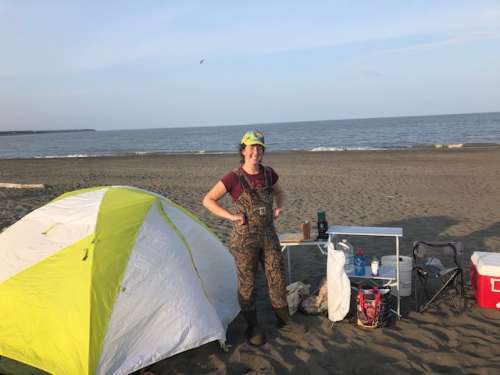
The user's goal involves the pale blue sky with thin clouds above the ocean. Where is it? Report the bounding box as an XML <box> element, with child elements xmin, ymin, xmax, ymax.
<box><xmin>0</xmin><ymin>0</ymin><xmax>500</xmax><ymax>130</ymax></box>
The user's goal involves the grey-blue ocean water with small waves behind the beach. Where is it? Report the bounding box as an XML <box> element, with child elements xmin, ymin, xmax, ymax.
<box><xmin>0</xmin><ymin>112</ymin><xmax>500</xmax><ymax>159</ymax></box>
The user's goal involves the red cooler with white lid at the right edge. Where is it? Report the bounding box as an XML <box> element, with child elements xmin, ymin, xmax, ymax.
<box><xmin>470</xmin><ymin>251</ymin><xmax>500</xmax><ymax>309</ymax></box>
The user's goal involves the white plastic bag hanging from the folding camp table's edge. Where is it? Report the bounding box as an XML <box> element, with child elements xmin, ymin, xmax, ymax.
<box><xmin>326</xmin><ymin>240</ymin><xmax>351</xmax><ymax>322</ymax></box>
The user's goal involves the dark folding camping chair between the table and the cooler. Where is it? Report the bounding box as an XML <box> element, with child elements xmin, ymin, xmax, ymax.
<box><xmin>412</xmin><ymin>241</ymin><xmax>464</xmax><ymax>312</ymax></box>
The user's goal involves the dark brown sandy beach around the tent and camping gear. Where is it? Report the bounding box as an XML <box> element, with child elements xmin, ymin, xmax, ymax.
<box><xmin>0</xmin><ymin>147</ymin><xmax>500</xmax><ymax>375</ymax></box>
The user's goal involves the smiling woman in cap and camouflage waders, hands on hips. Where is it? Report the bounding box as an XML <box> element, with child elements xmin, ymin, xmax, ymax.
<box><xmin>203</xmin><ymin>131</ymin><xmax>306</xmax><ymax>346</ymax></box>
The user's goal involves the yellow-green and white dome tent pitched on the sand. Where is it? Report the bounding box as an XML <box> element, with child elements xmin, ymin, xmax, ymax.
<box><xmin>0</xmin><ymin>187</ymin><xmax>239</xmax><ymax>375</ymax></box>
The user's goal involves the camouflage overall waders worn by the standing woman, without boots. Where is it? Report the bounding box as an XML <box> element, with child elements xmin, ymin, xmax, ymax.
<box><xmin>229</xmin><ymin>167</ymin><xmax>287</xmax><ymax>312</ymax></box>
